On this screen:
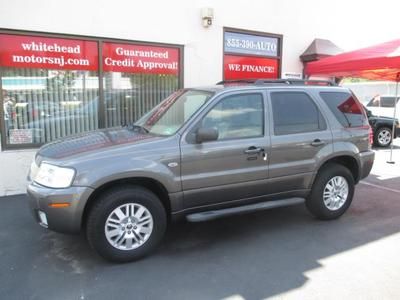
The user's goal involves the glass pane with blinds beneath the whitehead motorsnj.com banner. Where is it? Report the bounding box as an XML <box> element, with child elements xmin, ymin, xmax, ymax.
<box><xmin>1</xmin><ymin>68</ymin><xmax>98</xmax><ymax>144</ymax></box>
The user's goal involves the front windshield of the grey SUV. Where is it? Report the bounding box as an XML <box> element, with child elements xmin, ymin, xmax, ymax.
<box><xmin>135</xmin><ymin>90</ymin><xmax>213</xmax><ymax>135</ymax></box>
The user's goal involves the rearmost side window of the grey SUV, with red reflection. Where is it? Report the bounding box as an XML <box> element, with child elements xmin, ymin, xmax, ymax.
<box><xmin>320</xmin><ymin>92</ymin><xmax>368</xmax><ymax>128</ymax></box>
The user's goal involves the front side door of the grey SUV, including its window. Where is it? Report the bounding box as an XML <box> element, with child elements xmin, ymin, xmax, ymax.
<box><xmin>181</xmin><ymin>92</ymin><xmax>269</xmax><ymax>208</ymax></box>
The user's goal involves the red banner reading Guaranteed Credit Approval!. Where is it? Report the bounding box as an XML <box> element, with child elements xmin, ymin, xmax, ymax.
<box><xmin>103</xmin><ymin>43</ymin><xmax>179</xmax><ymax>75</ymax></box>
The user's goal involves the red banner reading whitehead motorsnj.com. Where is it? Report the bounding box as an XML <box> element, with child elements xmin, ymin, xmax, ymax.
<box><xmin>0</xmin><ymin>34</ymin><xmax>98</xmax><ymax>71</ymax></box>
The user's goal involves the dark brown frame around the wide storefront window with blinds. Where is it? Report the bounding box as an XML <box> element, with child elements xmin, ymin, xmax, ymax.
<box><xmin>0</xmin><ymin>28</ymin><xmax>184</xmax><ymax>151</ymax></box>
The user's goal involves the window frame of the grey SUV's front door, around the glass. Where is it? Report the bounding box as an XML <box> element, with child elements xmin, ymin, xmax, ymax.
<box><xmin>187</xmin><ymin>90</ymin><xmax>268</xmax><ymax>144</ymax></box>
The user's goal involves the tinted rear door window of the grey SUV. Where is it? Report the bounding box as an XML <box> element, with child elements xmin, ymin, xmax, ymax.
<box><xmin>271</xmin><ymin>92</ymin><xmax>326</xmax><ymax>135</ymax></box>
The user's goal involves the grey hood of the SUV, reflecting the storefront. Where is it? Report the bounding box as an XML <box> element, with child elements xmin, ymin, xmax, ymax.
<box><xmin>37</xmin><ymin>127</ymin><xmax>161</xmax><ymax>159</ymax></box>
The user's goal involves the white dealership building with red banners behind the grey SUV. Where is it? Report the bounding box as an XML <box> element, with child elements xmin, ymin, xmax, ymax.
<box><xmin>0</xmin><ymin>0</ymin><xmax>397</xmax><ymax>196</ymax></box>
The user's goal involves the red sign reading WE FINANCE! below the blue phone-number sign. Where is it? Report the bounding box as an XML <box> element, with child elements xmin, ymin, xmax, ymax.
<box><xmin>224</xmin><ymin>55</ymin><xmax>279</xmax><ymax>80</ymax></box>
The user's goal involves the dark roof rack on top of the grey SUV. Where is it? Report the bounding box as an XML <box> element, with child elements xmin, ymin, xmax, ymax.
<box><xmin>217</xmin><ymin>79</ymin><xmax>337</xmax><ymax>86</ymax></box>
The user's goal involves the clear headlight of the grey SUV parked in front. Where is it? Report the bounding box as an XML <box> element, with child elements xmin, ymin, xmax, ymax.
<box><xmin>34</xmin><ymin>163</ymin><xmax>75</xmax><ymax>188</ymax></box>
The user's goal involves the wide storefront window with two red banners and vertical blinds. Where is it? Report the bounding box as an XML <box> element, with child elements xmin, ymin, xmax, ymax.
<box><xmin>0</xmin><ymin>33</ymin><xmax>181</xmax><ymax>148</ymax></box>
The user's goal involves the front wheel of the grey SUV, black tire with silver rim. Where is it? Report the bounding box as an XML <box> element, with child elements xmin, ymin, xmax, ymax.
<box><xmin>86</xmin><ymin>186</ymin><xmax>167</xmax><ymax>262</ymax></box>
